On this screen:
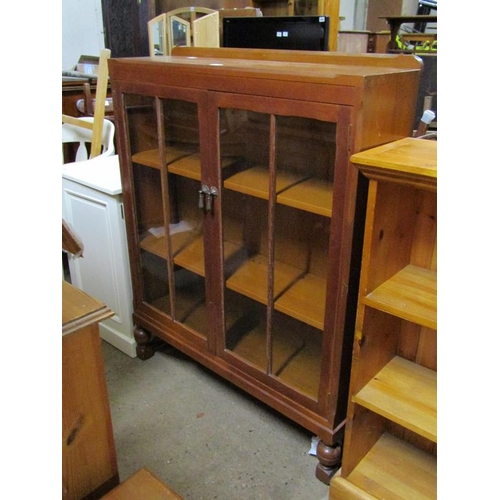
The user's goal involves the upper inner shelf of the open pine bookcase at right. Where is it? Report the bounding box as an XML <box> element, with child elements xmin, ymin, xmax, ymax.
<box><xmin>363</xmin><ymin>265</ymin><xmax>437</xmax><ymax>330</ymax></box>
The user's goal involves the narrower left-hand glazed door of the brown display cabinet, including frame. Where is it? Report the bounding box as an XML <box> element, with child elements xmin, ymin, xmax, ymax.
<box><xmin>121</xmin><ymin>89</ymin><xmax>212</xmax><ymax>345</ymax></box>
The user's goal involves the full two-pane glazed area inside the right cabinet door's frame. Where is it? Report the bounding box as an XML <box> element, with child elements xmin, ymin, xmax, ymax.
<box><xmin>220</xmin><ymin>105</ymin><xmax>336</xmax><ymax>399</ymax></box>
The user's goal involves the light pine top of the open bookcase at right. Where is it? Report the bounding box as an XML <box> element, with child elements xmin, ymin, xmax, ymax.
<box><xmin>351</xmin><ymin>137</ymin><xmax>437</xmax><ymax>179</ymax></box>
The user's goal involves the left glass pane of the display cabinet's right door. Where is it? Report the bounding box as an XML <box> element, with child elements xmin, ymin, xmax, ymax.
<box><xmin>220</xmin><ymin>109</ymin><xmax>270</xmax><ymax>371</ymax></box>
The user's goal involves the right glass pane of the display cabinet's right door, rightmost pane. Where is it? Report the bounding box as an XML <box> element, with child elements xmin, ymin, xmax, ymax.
<box><xmin>271</xmin><ymin>116</ymin><xmax>336</xmax><ymax>399</ymax></box>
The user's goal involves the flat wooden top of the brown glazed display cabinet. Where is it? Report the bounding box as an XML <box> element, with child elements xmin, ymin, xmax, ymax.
<box><xmin>109</xmin><ymin>49</ymin><xmax>421</xmax><ymax>86</ymax></box>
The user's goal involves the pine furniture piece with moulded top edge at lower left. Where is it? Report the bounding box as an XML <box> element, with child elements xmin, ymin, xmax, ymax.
<box><xmin>62</xmin><ymin>281</ymin><xmax>119</xmax><ymax>500</ymax></box>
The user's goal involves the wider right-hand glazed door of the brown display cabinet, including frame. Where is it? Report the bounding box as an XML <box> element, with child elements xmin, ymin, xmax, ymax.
<box><xmin>211</xmin><ymin>94</ymin><xmax>350</xmax><ymax>413</ymax></box>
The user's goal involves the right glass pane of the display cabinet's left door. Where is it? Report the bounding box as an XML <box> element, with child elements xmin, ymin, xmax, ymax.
<box><xmin>161</xmin><ymin>99</ymin><xmax>207</xmax><ymax>336</ymax></box>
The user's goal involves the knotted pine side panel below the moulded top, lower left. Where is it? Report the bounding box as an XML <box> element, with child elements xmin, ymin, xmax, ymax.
<box><xmin>62</xmin><ymin>325</ymin><xmax>119</xmax><ymax>498</ymax></box>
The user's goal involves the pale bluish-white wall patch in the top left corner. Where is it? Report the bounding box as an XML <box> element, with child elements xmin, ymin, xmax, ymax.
<box><xmin>62</xmin><ymin>0</ymin><xmax>105</xmax><ymax>70</ymax></box>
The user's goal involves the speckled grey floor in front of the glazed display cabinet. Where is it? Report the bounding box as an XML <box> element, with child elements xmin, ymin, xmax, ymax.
<box><xmin>102</xmin><ymin>341</ymin><xmax>328</xmax><ymax>500</ymax></box>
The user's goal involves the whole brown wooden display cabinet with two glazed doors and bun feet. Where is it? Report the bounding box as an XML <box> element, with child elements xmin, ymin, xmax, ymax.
<box><xmin>109</xmin><ymin>49</ymin><xmax>420</xmax><ymax>482</ymax></box>
